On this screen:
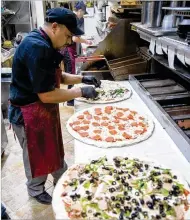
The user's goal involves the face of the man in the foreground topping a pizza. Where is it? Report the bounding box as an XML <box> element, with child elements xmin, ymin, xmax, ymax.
<box><xmin>52</xmin><ymin>23</ymin><xmax>72</xmax><ymax>50</ymax></box>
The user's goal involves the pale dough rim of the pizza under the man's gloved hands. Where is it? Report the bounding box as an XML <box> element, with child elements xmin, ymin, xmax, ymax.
<box><xmin>75</xmin><ymin>80</ymin><xmax>132</xmax><ymax>104</ymax></box>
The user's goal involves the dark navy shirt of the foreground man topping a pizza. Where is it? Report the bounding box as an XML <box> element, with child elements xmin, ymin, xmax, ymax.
<box><xmin>9</xmin><ymin>30</ymin><xmax>63</xmax><ymax>124</ymax></box>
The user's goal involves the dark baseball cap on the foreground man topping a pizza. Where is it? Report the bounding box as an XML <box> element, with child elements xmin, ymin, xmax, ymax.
<box><xmin>45</xmin><ymin>8</ymin><xmax>84</xmax><ymax>36</ymax></box>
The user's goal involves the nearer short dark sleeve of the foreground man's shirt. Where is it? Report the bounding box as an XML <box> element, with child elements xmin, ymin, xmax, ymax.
<box><xmin>24</xmin><ymin>44</ymin><xmax>56</xmax><ymax>93</ymax></box>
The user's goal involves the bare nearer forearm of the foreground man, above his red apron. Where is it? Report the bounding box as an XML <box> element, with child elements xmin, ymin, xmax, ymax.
<box><xmin>38</xmin><ymin>88</ymin><xmax>82</xmax><ymax>103</ymax></box>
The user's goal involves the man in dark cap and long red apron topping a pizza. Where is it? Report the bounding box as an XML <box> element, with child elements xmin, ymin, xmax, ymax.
<box><xmin>9</xmin><ymin>8</ymin><xmax>100</xmax><ymax>204</ymax></box>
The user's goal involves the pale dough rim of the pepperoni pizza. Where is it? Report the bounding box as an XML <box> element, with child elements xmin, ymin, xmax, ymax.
<box><xmin>66</xmin><ymin>107</ymin><xmax>154</xmax><ymax>148</ymax></box>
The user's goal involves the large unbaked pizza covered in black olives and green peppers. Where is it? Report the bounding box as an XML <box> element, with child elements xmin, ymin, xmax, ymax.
<box><xmin>52</xmin><ymin>157</ymin><xmax>190</xmax><ymax>220</ymax></box>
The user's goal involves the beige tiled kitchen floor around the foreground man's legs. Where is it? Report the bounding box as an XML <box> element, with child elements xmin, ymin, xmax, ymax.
<box><xmin>1</xmin><ymin>104</ymin><xmax>74</xmax><ymax>220</ymax></box>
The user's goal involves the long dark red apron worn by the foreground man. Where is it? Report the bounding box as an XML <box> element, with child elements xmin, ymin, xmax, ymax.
<box><xmin>21</xmin><ymin>69</ymin><xmax>64</xmax><ymax>178</ymax></box>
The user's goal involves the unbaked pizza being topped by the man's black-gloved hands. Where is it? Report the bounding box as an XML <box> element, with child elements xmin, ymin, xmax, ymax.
<box><xmin>75</xmin><ymin>80</ymin><xmax>131</xmax><ymax>104</ymax></box>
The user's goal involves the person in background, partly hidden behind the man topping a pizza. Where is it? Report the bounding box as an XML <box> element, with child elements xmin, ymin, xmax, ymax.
<box><xmin>60</xmin><ymin>1</ymin><xmax>92</xmax><ymax>106</ymax></box>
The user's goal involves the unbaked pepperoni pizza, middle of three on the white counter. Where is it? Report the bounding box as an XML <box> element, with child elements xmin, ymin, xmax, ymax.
<box><xmin>67</xmin><ymin>106</ymin><xmax>154</xmax><ymax>148</ymax></box>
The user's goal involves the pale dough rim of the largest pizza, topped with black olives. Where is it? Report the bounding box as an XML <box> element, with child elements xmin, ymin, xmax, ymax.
<box><xmin>52</xmin><ymin>157</ymin><xmax>190</xmax><ymax>219</ymax></box>
